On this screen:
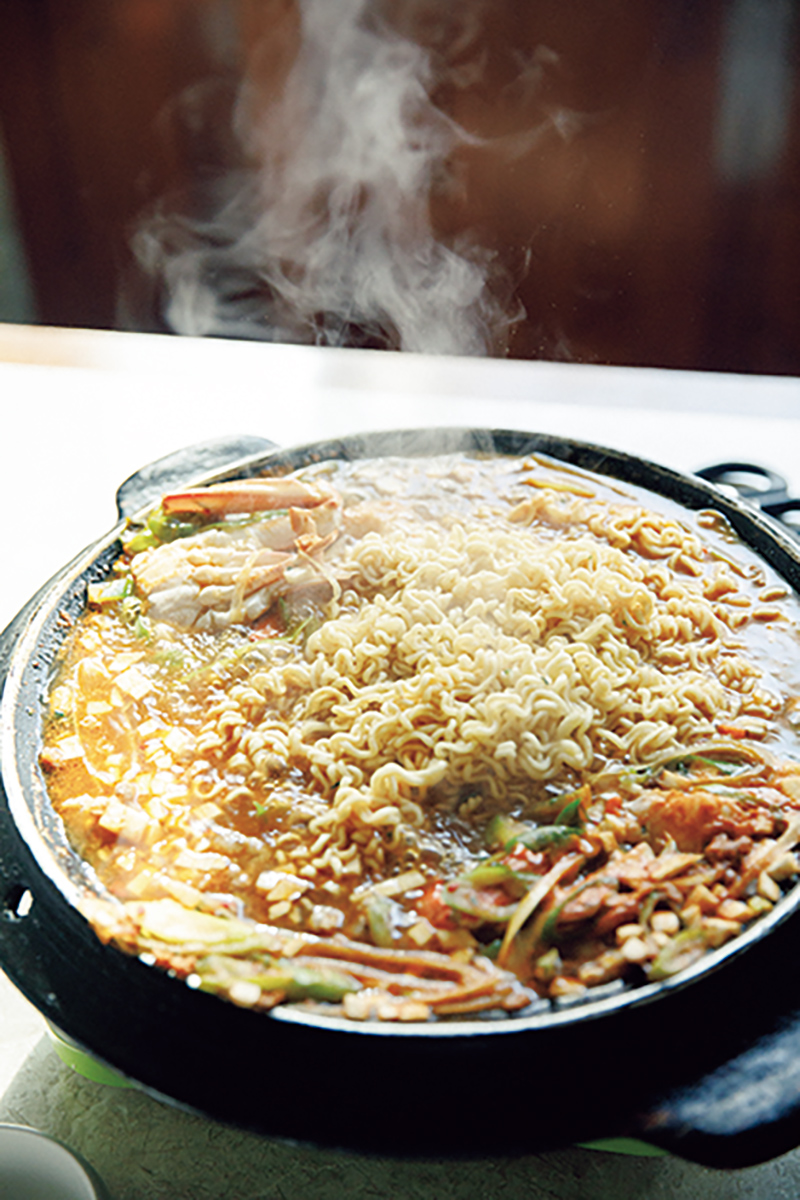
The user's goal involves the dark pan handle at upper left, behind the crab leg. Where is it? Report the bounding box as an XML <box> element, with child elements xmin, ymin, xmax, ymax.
<box><xmin>116</xmin><ymin>434</ymin><xmax>276</xmax><ymax>520</ymax></box>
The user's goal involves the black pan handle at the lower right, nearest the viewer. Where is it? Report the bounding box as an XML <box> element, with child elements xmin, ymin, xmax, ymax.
<box><xmin>636</xmin><ymin>1014</ymin><xmax>800</xmax><ymax>1168</ymax></box>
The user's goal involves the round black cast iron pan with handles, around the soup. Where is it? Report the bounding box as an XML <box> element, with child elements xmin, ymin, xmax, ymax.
<box><xmin>0</xmin><ymin>430</ymin><xmax>800</xmax><ymax>1166</ymax></box>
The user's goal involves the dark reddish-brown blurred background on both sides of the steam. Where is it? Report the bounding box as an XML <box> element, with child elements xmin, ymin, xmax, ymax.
<box><xmin>0</xmin><ymin>0</ymin><xmax>800</xmax><ymax>374</ymax></box>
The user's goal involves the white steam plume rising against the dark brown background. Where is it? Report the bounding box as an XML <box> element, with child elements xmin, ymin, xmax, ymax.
<box><xmin>134</xmin><ymin>0</ymin><xmax>522</xmax><ymax>354</ymax></box>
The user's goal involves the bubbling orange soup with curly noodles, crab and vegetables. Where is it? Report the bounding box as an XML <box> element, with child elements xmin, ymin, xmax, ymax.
<box><xmin>41</xmin><ymin>454</ymin><xmax>800</xmax><ymax>1021</ymax></box>
